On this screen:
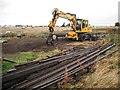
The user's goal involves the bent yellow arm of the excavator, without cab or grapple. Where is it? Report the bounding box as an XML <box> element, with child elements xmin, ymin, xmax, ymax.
<box><xmin>48</xmin><ymin>8</ymin><xmax>76</xmax><ymax>32</ymax></box>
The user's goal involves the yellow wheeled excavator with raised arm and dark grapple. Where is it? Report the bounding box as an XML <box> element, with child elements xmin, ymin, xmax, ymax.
<box><xmin>47</xmin><ymin>8</ymin><xmax>97</xmax><ymax>44</ymax></box>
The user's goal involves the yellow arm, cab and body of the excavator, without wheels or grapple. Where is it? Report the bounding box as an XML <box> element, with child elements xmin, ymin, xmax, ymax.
<box><xmin>48</xmin><ymin>8</ymin><xmax>92</xmax><ymax>40</ymax></box>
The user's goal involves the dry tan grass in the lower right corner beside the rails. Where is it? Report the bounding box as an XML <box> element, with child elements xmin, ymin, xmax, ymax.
<box><xmin>79</xmin><ymin>53</ymin><xmax>118</xmax><ymax>88</ymax></box>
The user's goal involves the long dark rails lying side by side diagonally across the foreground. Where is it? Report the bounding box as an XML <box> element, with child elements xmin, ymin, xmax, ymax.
<box><xmin>2</xmin><ymin>43</ymin><xmax>115</xmax><ymax>90</ymax></box>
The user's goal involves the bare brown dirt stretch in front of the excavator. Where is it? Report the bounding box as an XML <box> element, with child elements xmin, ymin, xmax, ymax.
<box><xmin>2</xmin><ymin>38</ymin><xmax>103</xmax><ymax>54</ymax></box>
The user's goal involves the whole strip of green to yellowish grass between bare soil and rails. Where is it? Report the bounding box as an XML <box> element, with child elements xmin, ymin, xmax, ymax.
<box><xmin>2</xmin><ymin>49</ymin><xmax>61</xmax><ymax>73</ymax></box>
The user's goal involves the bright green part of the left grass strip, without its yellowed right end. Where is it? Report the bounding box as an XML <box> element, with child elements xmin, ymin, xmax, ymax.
<box><xmin>2</xmin><ymin>52</ymin><xmax>37</xmax><ymax>73</ymax></box>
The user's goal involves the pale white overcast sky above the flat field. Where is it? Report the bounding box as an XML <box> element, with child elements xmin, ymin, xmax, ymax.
<box><xmin>0</xmin><ymin>0</ymin><xmax>120</xmax><ymax>25</ymax></box>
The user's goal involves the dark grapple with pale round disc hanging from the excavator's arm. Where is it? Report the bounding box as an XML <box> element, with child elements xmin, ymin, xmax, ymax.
<box><xmin>46</xmin><ymin>34</ymin><xmax>58</xmax><ymax>45</ymax></box>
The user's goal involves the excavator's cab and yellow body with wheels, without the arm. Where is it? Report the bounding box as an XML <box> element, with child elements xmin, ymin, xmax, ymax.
<box><xmin>66</xmin><ymin>19</ymin><xmax>92</xmax><ymax>41</ymax></box>
